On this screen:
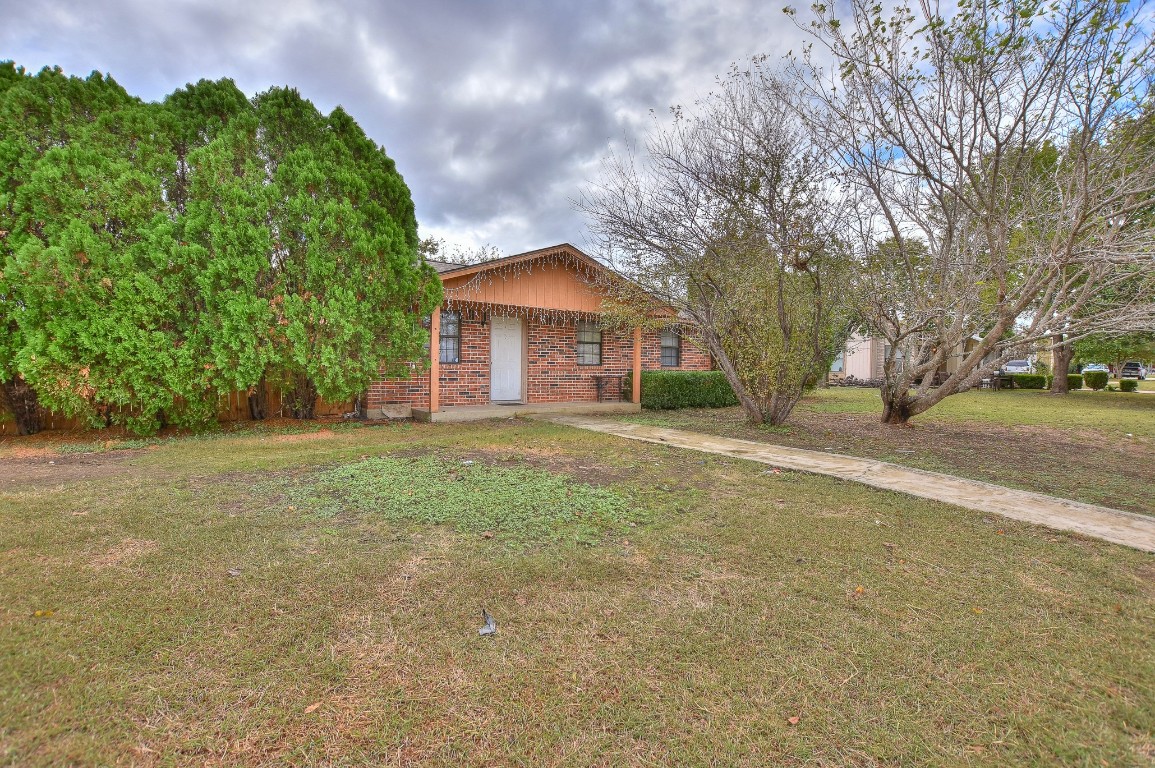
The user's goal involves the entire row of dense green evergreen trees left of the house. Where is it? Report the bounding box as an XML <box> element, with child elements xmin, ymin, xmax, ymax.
<box><xmin>0</xmin><ymin>65</ymin><xmax>440</xmax><ymax>432</ymax></box>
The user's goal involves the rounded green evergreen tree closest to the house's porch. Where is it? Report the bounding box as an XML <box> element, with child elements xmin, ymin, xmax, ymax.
<box><xmin>187</xmin><ymin>89</ymin><xmax>440</xmax><ymax>417</ymax></box>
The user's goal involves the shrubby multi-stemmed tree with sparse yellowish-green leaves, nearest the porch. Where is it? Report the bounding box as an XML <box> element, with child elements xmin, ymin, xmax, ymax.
<box><xmin>575</xmin><ymin>69</ymin><xmax>852</xmax><ymax>424</ymax></box>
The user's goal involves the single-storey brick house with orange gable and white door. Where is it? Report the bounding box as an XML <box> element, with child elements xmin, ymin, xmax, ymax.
<box><xmin>365</xmin><ymin>244</ymin><xmax>713</xmax><ymax>422</ymax></box>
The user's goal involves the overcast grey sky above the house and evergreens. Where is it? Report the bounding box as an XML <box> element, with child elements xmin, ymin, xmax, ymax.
<box><xmin>0</xmin><ymin>0</ymin><xmax>806</xmax><ymax>253</ymax></box>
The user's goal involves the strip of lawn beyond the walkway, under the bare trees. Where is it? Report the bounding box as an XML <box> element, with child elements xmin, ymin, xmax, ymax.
<box><xmin>621</xmin><ymin>388</ymin><xmax>1155</xmax><ymax>514</ymax></box>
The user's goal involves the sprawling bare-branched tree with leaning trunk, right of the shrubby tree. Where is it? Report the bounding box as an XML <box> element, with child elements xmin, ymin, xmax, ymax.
<box><xmin>788</xmin><ymin>0</ymin><xmax>1155</xmax><ymax>423</ymax></box>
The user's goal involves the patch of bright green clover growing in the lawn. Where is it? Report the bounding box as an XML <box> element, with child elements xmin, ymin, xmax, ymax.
<box><xmin>280</xmin><ymin>456</ymin><xmax>639</xmax><ymax>546</ymax></box>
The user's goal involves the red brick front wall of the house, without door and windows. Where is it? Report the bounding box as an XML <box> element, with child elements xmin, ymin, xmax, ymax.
<box><xmin>367</xmin><ymin>304</ymin><xmax>713</xmax><ymax>410</ymax></box>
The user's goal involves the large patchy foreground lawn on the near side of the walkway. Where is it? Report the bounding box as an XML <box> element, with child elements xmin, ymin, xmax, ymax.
<box><xmin>0</xmin><ymin>422</ymin><xmax>1155</xmax><ymax>766</ymax></box>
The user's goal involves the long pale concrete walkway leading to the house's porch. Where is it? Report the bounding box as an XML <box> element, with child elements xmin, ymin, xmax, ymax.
<box><xmin>547</xmin><ymin>416</ymin><xmax>1155</xmax><ymax>552</ymax></box>
